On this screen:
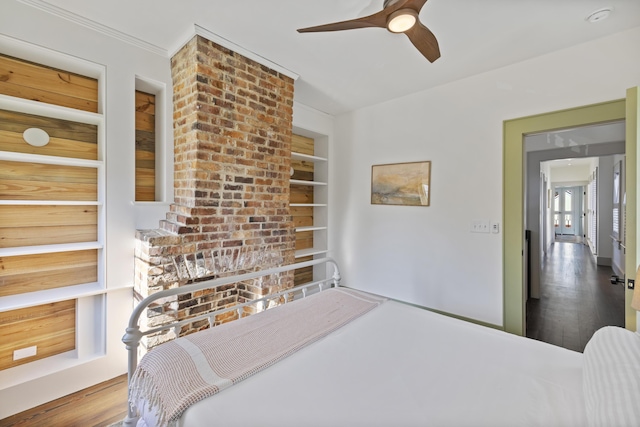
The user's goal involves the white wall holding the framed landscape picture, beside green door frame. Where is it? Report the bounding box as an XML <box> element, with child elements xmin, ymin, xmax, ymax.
<box><xmin>330</xmin><ymin>28</ymin><xmax>640</xmax><ymax>325</ymax></box>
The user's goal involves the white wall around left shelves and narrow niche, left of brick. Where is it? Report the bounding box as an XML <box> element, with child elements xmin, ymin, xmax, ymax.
<box><xmin>0</xmin><ymin>1</ymin><xmax>173</xmax><ymax>419</ymax></box>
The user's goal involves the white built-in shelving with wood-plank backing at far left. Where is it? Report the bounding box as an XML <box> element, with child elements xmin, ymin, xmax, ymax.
<box><xmin>0</xmin><ymin>36</ymin><xmax>112</xmax><ymax>390</ymax></box>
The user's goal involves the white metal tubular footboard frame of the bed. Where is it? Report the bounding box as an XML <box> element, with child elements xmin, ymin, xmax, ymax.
<box><xmin>122</xmin><ymin>258</ymin><xmax>341</xmax><ymax>427</ymax></box>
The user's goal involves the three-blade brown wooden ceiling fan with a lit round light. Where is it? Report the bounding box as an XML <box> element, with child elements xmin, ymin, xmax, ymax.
<box><xmin>298</xmin><ymin>0</ymin><xmax>440</xmax><ymax>62</ymax></box>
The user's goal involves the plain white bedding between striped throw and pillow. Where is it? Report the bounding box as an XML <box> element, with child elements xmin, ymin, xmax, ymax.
<box><xmin>138</xmin><ymin>301</ymin><xmax>587</xmax><ymax>427</ymax></box>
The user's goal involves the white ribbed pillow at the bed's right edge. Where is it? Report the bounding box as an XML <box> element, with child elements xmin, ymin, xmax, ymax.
<box><xmin>583</xmin><ymin>326</ymin><xmax>640</xmax><ymax>427</ymax></box>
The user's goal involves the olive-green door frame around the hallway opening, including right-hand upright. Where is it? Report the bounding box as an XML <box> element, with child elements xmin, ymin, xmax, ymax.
<box><xmin>503</xmin><ymin>94</ymin><xmax>640</xmax><ymax>335</ymax></box>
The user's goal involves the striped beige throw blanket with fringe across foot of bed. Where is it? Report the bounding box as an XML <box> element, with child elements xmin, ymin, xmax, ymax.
<box><xmin>129</xmin><ymin>288</ymin><xmax>385</xmax><ymax>425</ymax></box>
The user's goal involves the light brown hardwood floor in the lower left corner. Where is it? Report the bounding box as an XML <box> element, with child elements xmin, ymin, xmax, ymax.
<box><xmin>0</xmin><ymin>375</ymin><xmax>127</xmax><ymax>427</ymax></box>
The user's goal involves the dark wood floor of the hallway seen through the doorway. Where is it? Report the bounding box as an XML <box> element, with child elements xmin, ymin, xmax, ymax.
<box><xmin>527</xmin><ymin>241</ymin><xmax>624</xmax><ymax>352</ymax></box>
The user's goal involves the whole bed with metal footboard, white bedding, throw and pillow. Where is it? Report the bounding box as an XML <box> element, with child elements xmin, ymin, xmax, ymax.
<box><xmin>123</xmin><ymin>258</ymin><xmax>640</xmax><ymax>427</ymax></box>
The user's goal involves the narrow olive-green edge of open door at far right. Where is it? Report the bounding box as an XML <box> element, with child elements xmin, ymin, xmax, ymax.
<box><xmin>623</xmin><ymin>87</ymin><xmax>640</xmax><ymax>331</ymax></box>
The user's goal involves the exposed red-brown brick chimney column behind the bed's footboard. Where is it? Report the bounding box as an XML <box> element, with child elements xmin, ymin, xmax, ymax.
<box><xmin>136</xmin><ymin>36</ymin><xmax>295</xmax><ymax>346</ymax></box>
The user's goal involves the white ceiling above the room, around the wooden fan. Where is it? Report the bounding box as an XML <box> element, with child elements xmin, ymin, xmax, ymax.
<box><xmin>20</xmin><ymin>0</ymin><xmax>640</xmax><ymax>114</ymax></box>
